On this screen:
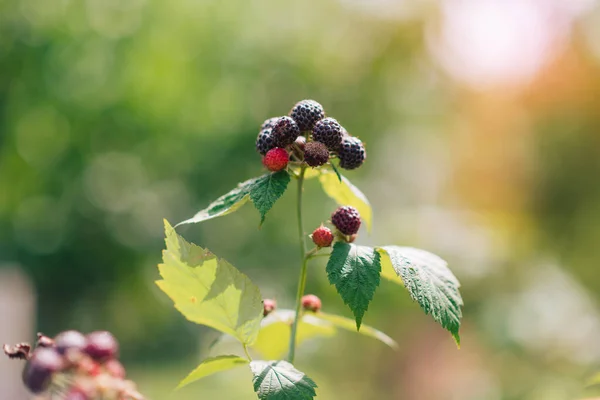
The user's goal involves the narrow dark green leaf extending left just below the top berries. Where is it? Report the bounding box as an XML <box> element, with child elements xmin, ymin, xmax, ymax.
<box><xmin>176</xmin><ymin>171</ymin><xmax>290</xmax><ymax>226</ymax></box>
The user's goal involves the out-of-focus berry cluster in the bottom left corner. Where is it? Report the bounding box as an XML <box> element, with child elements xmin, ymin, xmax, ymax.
<box><xmin>3</xmin><ymin>331</ymin><xmax>144</xmax><ymax>400</ymax></box>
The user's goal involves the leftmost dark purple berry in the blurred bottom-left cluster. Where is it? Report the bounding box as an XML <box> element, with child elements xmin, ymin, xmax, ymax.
<box><xmin>23</xmin><ymin>347</ymin><xmax>65</xmax><ymax>394</ymax></box>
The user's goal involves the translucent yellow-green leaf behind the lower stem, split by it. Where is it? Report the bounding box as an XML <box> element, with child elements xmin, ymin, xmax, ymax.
<box><xmin>252</xmin><ymin>309</ymin><xmax>336</xmax><ymax>359</ymax></box>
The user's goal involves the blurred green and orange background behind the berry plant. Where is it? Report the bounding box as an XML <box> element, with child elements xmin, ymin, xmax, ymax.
<box><xmin>0</xmin><ymin>0</ymin><xmax>600</xmax><ymax>400</ymax></box>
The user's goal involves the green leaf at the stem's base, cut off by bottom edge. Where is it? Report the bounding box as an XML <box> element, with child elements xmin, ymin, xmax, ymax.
<box><xmin>250</xmin><ymin>361</ymin><xmax>317</xmax><ymax>400</ymax></box>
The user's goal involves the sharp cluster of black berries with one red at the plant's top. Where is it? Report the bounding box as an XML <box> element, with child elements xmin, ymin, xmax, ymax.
<box><xmin>256</xmin><ymin>100</ymin><xmax>367</xmax><ymax>171</ymax></box>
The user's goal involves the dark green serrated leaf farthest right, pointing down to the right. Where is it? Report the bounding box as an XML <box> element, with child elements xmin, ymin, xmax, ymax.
<box><xmin>378</xmin><ymin>246</ymin><xmax>463</xmax><ymax>346</ymax></box>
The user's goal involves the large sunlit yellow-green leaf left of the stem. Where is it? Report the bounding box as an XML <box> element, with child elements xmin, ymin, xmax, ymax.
<box><xmin>156</xmin><ymin>221</ymin><xmax>263</xmax><ymax>345</ymax></box>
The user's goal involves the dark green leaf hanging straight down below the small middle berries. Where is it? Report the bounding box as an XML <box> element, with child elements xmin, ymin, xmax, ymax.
<box><xmin>326</xmin><ymin>242</ymin><xmax>381</xmax><ymax>329</ymax></box>
